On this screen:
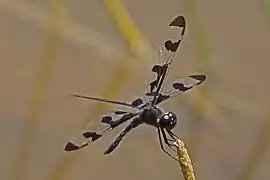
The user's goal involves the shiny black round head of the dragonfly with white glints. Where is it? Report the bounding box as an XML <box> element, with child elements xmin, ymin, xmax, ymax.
<box><xmin>159</xmin><ymin>112</ymin><xmax>177</xmax><ymax>130</ymax></box>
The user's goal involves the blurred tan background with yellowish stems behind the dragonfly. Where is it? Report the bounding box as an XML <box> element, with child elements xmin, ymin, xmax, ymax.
<box><xmin>0</xmin><ymin>0</ymin><xmax>270</xmax><ymax>180</ymax></box>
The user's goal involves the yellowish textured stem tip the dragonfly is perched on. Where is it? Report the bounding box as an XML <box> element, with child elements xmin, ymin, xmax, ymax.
<box><xmin>175</xmin><ymin>139</ymin><xmax>195</xmax><ymax>180</ymax></box>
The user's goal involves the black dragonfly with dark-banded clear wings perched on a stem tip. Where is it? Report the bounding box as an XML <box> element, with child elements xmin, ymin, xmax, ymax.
<box><xmin>64</xmin><ymin>15</ymin><xmax>206</xmax><ymax>161</ymax></box>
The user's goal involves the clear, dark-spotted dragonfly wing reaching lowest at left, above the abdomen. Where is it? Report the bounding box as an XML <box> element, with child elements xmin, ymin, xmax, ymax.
<box><xmin>65</xmin><ymin>110</ymin><xmax>137</xmax><ymax>151</ymax></box>
